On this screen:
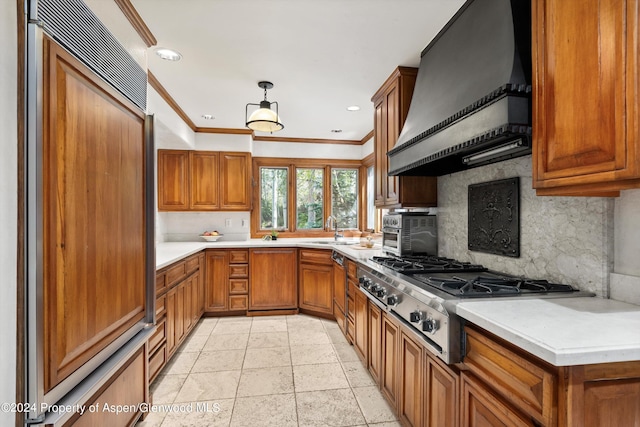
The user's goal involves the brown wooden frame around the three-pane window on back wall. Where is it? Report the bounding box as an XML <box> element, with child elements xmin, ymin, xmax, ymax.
<box><xmin>251</xmin><ymin>157</ymin><xmax>366</xmax><ymax>238</ymax></box>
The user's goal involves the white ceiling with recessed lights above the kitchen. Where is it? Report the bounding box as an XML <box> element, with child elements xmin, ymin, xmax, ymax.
<box><xmin>132</xmin><ymin>0</ymin><xmax>464</xmax><ymax>140</ymax></box>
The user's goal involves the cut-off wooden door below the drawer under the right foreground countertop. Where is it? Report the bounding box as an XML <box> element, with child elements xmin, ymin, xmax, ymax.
<box><xmin>461</xmin><ymin>374</ymin><xmax>539</xmax><ymax>427</ymax></box>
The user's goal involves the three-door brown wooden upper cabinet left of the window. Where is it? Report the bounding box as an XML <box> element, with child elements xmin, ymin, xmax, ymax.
<box><xmin>158</xmin><ymin>150</ymin><xmax>251</xmax><ymax>211</ymax></box>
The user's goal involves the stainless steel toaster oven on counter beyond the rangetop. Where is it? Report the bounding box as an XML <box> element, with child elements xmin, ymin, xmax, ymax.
<box><xmin>382</xmin><ymin>212</ymin><xmax>438</xmax><ymax>256</ymax></box>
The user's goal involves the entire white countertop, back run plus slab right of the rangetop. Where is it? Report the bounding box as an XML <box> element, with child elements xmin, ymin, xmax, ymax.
<box><xmin>156</xmin><ymin>238</ymin><xmax>640</xmax><ymax>366</ymax></box>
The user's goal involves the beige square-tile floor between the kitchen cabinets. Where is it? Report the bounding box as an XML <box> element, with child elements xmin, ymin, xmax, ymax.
<box><xmin>138</xmin><ymin>315</ymin><xmax>400</xmax><ymax>427</ymax></box>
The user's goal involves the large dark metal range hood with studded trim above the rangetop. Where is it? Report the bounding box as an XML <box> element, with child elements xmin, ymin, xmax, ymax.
<box><xmin>387</xmin><ymin>0</ymin><xmax>531</xmax><ymax>176</ymax></box>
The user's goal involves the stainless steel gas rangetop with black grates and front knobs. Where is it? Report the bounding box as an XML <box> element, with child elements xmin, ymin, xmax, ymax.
<box><xmin>358</xmin><ymin>256</ymin><xmax>592</xmax><ymax>363</ymax></box>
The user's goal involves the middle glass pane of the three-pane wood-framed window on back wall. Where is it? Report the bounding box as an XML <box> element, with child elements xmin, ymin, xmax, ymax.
<box><xmin>296</xmin><ymin>168</ymin><xmax>324</xmax><ymax>230</ymax></box>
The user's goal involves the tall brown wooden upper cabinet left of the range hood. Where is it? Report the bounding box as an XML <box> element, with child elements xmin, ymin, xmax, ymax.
<box><xmin>371</xmin><ymin>67</ymin><xmax>437</xmax><ymax>208</ymax></box>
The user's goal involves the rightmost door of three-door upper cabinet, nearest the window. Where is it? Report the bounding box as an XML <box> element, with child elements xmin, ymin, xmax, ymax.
<box><xmin>220</xmin><ymin>152</ymin><xmax>251</xmax><ymax>211</ymax></box>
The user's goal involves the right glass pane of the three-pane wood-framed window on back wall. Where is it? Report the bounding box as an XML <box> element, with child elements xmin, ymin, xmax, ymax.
<box><xmin>331</xmin><ymin>169</ymin><xmax>358</xmax><ymax>229</ymax></box>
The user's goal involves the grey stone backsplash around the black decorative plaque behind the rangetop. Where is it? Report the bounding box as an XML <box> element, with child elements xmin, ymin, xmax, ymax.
<box><xmin>438</xmin><ymin>156</ymin><xmax>614</xmax><ymax>298</ymax></box>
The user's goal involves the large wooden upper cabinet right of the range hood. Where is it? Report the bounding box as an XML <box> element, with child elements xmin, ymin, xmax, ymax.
<box><xmin>532</xmin><ymin>0</ymin><xmax>640</xmax><ymax>195</ymax></box>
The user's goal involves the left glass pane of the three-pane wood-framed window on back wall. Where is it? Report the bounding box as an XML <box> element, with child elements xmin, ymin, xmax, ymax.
<box><xmin>260</xmin><ymin>167</ymin><xmax>289</xmax><ymax>230</ymax></box>
